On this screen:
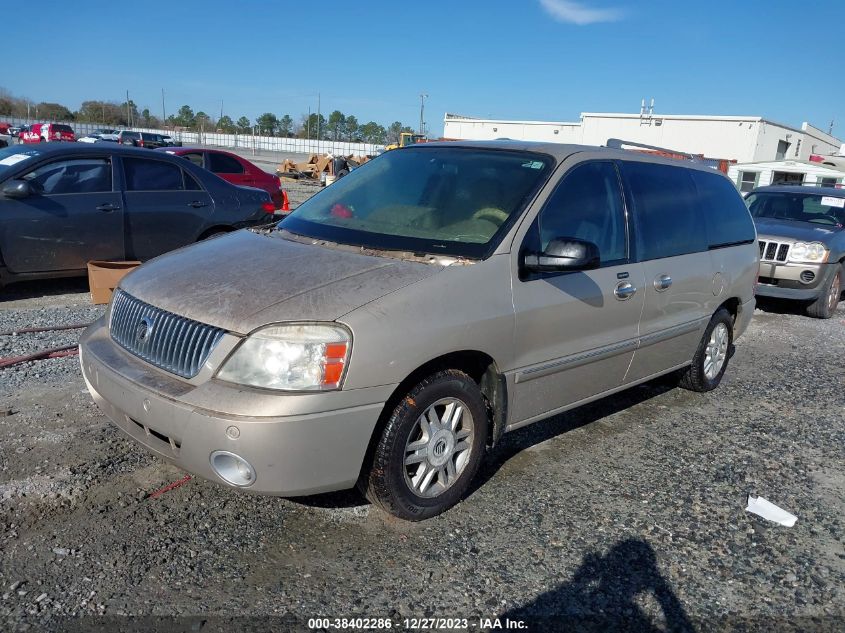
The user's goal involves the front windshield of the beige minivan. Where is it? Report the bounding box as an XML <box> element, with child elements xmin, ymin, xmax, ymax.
<box><xmin>279</xmin><ymin>146</ymin><xmax>552</xmax><ymax>258</ymax></box>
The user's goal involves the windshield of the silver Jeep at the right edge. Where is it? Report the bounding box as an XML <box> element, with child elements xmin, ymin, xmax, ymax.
<box><xmin>745</xmin><ymin>191</ymin><xmax>845</xmax><ymax>227</ymax></box>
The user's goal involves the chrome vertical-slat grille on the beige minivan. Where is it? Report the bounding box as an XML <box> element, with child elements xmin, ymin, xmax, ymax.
<box><xmin>109</xmin><ymin>290</ymin><xmax>225</xmax><ymax>378</ymax></box>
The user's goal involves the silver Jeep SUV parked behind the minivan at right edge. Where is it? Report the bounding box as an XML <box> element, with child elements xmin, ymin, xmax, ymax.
<box><xmin>745</xmin><ymin>185</ymin><xmax>845</xmax><ymax>319</ymax></box>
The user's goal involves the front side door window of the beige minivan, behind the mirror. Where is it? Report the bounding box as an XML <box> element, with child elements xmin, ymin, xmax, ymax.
<box><xmin>536</xmin><ymin>162</ymin><xmax>628</xmax><ymax>265</ymax></box>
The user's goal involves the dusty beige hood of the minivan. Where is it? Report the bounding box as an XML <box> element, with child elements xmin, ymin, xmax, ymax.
<box><xmin>120</xmin><ymin>231</ymin><xmax>443</xmax><ymax>334</ymax></box>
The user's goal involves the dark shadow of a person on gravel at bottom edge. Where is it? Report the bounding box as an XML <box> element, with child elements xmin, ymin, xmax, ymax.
<box><xmin>500</xmin><ymin>539</ymin><xmax>695</xmax><ymax>633</ymax></box>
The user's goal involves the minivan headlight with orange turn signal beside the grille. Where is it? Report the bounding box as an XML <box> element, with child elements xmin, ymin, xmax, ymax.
<box><xmin>217</xmin><ymin>324</ymin><xmax>352</xmax><ymax>391</ymax></box>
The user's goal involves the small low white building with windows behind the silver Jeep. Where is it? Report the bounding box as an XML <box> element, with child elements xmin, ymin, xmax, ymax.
<box><xmin>728</xmin><ymin>160</ymin><xmax>845</xmax><ymax>193</ymax></box>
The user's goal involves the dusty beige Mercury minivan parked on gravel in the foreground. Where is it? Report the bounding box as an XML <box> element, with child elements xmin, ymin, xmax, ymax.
<box><xmin>76</xmin><ymin>142</ymin><xmax>758</xmax><ymax>520</ymax></box>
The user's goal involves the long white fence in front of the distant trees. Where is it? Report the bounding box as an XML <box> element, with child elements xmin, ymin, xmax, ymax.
<box><xmin>0</xmin><ymin>117</ymin><xmax>384</xmax><ymax>156</ymax></box>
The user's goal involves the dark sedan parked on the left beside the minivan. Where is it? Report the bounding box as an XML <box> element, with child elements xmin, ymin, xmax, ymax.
<box><xmin>0</xmin><ymin>143</ymin><xmax>273</xmax><ymax>284</ymax></box>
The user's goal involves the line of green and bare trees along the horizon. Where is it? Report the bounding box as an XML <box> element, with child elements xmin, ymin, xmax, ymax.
<box><xmin>0</xmin><ymin>88</ymin><xmax>413</xmax><ymax>144</ymax></box>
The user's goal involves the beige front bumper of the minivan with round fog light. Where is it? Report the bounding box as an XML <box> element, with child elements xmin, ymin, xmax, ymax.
<box><xmin>80</xmin><ymin>319</ymin><xmax>393</xmax><ymax>496</ymax></box>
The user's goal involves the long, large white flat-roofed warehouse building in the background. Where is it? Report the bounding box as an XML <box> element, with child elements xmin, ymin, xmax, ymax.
<box><xmin>443</xmin><ymin>112</ymin><xmax>843</xmax><ymax>163</ymax></box>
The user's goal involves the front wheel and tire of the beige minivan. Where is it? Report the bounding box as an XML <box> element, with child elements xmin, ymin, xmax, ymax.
<box><xmin>359</xmin><ymin>369</ymin><xmax>489</xmax><ymax>521</ymax></box>
